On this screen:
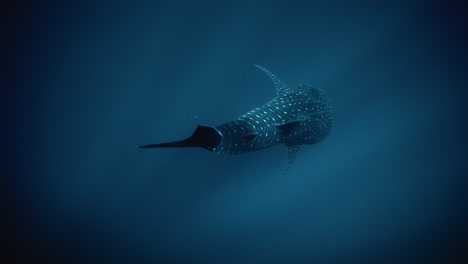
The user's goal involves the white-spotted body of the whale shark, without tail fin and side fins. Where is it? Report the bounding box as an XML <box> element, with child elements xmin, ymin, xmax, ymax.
<box><xmin>213</xmin><ymin>86</ymin><xmax>332</xmax><ymax>154</ymax></box>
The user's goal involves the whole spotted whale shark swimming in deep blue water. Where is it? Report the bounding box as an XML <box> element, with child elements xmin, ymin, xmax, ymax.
<box><xmin>139</xmin><ymin>65</ymin><xmax>332</xmax><ymax>172</ymax></box>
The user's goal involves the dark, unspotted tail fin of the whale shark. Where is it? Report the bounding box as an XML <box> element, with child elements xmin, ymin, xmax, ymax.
<box><xmin>138</xmin><ymin>126</ymin><xmax>222</xmax><ymax>150</ymax></box>
